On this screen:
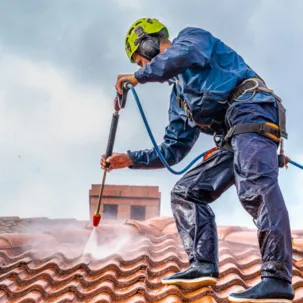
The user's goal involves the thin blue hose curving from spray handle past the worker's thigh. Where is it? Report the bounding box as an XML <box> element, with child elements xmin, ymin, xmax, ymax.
<box><xmin>127</xmin><ymin>83</ymin><xmax>303</xmax><ymax>175</ymax></box>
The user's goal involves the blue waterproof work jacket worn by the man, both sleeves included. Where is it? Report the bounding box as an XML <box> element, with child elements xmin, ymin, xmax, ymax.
<box><xmin>128</xmin><ymin>27</ymin><xmax>268</xmax><ymax>169</ymax></box>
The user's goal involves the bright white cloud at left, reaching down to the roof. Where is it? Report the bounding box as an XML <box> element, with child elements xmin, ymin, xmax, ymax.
<box><xmin>0</xmin><ymin>55</ymin><xmax>112</xmax><ymax>216</ymax></box>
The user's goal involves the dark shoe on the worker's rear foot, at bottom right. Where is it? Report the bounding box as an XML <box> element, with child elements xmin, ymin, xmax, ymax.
<box><xmin>228</xmin><ymin>278</ymin><xmax>295</xmax><ymax>303</ymax></box>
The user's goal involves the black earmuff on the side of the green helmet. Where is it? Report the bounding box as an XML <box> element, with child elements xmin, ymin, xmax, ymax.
<box><xmin>135</xmin><ymin>26</ymin><xmax>163</xmax><ymax>61</ymax></box>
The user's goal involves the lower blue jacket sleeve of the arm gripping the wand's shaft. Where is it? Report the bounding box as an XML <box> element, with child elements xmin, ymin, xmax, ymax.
<box><xmin>127</xmin><ymin>87</ymin><xmax>200</xmax><ymax>169</ymax></box>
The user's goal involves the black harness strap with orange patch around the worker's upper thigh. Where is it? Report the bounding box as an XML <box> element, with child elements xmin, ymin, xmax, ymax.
<box><xmin>225</xmin><ymin>122</ymin><xmax>281</xmax><ymax>143</ymax></box>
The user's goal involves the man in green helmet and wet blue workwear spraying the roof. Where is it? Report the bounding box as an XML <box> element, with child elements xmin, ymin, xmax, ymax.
<box><xmin>100</xmin><ymin>18</ymin><xmax>294</xmax><ymax>302</ymax></box>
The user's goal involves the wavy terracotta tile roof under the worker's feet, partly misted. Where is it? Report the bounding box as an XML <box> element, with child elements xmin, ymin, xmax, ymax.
<box><xmin>0</xmin><ymin>217</ymin><xmax>303</xmax><ymax>303</ymax></box>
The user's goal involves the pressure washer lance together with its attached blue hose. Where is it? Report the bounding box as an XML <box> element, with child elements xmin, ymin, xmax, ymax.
<box><xmin>93</xmin><ymin>82</ymin><xmax>303</xmax><ymax>227</ymax></box>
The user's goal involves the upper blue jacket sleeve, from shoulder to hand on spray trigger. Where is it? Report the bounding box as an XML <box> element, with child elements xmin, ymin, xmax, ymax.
<box><xmin>134</xmin><ymin>28</ymin><xmax>217</xmax><ymax>84</ymax></box>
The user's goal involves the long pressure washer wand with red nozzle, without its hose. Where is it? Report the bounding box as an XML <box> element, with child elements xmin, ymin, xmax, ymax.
<box><xmin>93</xmin><ymin>83</ymin><xmax>128</xmax><ymax>227</ymax></box>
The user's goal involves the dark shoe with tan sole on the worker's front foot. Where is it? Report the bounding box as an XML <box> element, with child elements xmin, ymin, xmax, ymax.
<box><xmin>162</xmin><ymin>261</ymin><xmax>219</xmax><ymax>288</ymax></box>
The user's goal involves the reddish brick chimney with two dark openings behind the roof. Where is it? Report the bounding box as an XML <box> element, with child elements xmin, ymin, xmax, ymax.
<box><xmin>89</xmin><ymin>184</ymin><xmax>161</xmax><ymax>222</ymax></box>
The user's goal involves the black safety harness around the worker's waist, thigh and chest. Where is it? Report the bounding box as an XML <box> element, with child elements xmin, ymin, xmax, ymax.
<box><xmin>177</xmin><ymin>78</ymin><xmax>288</xmax><ymax>167</ymax></box>
